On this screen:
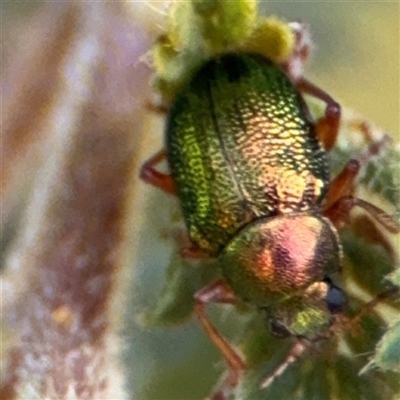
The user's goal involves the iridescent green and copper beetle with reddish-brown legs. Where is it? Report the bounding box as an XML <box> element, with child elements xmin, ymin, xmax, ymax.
<box><xmin>141</xmin><ymin>53</ymin><xmax>399</xmax><ymax>398</ymax></box>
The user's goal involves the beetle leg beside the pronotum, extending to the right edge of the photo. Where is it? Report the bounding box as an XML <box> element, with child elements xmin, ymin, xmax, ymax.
<box><xmin>324</xmin><ymin>196</ymin><xmax>400</xmax><ymax>233</ymax></box>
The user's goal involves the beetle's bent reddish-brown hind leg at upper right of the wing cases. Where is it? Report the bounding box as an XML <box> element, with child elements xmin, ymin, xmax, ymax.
<box><xmin>297</xmin><ymin>78</ymin><xmax>341</xmax><ymax>151</ymax></box>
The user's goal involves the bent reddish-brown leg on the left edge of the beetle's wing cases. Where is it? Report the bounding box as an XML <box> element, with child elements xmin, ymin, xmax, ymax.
<box><xmin>140</xmin><ymin>149</ymin><xmax>176</xmax><ymax>195</ymax></box>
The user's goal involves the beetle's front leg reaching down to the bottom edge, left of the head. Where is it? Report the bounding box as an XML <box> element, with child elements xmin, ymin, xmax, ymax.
<box><xmin>194</xmin><ymin>280</ymin><xmax>246</xmax><ymax>399</ymax></box>
